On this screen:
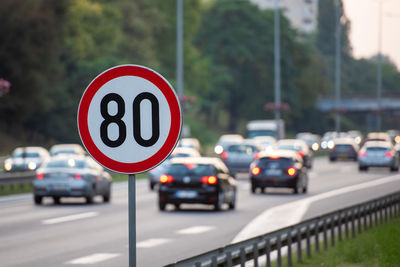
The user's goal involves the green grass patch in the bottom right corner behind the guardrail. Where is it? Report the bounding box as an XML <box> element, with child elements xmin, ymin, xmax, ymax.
<box><xmin>286</xmin><ymin>218</ymin><xmax>400</xmax><ymax>267</ymax></box>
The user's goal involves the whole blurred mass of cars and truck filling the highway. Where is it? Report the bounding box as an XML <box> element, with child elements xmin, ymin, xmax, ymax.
<box><xmin>3</xmin><ymin>124</ymin><xmax>400</xmax><ymax>211</ymax></box>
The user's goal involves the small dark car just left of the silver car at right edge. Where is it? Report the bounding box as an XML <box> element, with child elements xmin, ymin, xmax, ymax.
<box><xmin>329</xmin><ymin>138</ymin><xmax>360</xmax><ymax>161</ymax></box>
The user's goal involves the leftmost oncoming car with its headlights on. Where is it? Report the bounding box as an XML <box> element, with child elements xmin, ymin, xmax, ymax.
<box><xmin>4</xmin><ymin>146</ymin><xmax>50</xmax><ymax>172</ymax></box>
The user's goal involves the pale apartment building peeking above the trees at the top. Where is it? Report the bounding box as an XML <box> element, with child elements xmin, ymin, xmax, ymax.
<box><xmin>250</xmin><ymin>0</ymin><xmax>318</xmax><ymax>33</ymax></box>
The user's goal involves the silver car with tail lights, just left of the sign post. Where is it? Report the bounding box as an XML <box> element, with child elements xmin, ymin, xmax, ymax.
<box><xmin>33</xmin><ymin>154</ymin><xmax>112</xmax><ymax>205</ymax></box>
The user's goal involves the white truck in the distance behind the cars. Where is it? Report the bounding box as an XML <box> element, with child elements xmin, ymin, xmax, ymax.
<box><xmin>246</xmin><ymin>120</ymin><xmax>285</xmax><ymax>140</ymax></box>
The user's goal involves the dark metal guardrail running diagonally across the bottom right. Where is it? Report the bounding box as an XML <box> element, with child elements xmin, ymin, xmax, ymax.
<box><xmin>167</xmin><ymin>192</ymin><xmax>400</xmax><ymax>267</ymax></box>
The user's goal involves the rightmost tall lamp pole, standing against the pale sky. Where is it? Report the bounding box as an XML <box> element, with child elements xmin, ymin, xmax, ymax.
<box><xmin>376</xmin><ymin>0</ymin><xmax>382</xmax><ymax>132</ymax></box>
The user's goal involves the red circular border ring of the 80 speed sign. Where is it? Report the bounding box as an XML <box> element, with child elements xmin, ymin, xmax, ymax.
<box><xmin>78</xmin><ymin>65</ymin><xmax>182</xmax><ymax>174</ymax></box>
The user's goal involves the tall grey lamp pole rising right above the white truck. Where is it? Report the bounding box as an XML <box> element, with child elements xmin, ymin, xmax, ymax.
<box><xmin>274</xmin><ymin>0</ymin><xmax>281</xmax><ymax>139</ymax></box>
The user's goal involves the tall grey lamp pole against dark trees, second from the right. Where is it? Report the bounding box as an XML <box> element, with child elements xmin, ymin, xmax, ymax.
<box><xmin>335</xmin><ymin>0</ymin><xmax>342</xmax><ymax>132</ymax></box>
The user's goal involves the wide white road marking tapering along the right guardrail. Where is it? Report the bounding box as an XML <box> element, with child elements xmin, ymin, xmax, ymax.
<box><xmin>232</xmin><ymin>175</ymin><xmax>400</xmax><ymax>243</ymax></box>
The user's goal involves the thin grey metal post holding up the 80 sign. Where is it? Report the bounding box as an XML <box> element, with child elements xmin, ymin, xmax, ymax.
<box><xmin>128</xmin><ymin>174</ymin><xmax>136</xmax><ymax>267</ymax></box>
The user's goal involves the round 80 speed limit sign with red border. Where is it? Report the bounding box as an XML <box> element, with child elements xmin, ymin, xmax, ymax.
<box><xmin>78</xmin><ymin>65</ymin><xmax>182</xmax><ymax>174</ymax></box>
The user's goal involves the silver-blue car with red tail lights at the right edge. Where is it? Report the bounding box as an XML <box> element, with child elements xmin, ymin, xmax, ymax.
<box><xmin>358</xmin><ymin>141</ymin><xmax>399</xmax><ymax>171</ymax></box>
